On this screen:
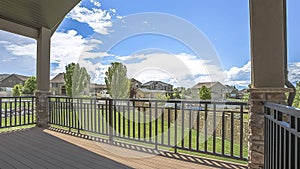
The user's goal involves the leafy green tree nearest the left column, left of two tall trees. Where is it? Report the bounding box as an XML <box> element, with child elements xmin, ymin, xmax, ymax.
<box><xmin>64</xmin><ymin>63</ymin><xmax>91</xmax><ymax>97</ymax></box>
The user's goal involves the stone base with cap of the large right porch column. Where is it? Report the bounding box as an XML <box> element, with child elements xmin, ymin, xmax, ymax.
<box><xmin>248</xmin><ymin>88</ymin><xmax>290</xmax><ymax>169</ymax></box>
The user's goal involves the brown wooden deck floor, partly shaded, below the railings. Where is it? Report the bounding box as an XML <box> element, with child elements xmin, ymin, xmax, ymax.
<box><xmin>0</xmin><ymin>128</ymin><xmax>246</xmax><ymax>169</ymax></box>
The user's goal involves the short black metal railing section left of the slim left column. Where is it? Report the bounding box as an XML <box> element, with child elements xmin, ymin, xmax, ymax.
<box><xmin>0</xmin><ymin>96</ymin><xmax>36</xmax><ymax>128</ymax></box>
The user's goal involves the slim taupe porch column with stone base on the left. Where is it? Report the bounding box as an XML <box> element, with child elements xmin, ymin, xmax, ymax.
<box><xmin>36</xmin><ymin>27</ymin><xmax>51</xmax><ymax>127</ymax></box>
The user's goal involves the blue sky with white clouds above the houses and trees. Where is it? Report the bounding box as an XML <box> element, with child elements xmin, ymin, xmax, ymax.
<box><xmin>0</xmin><ymin>0</ymin><xmax>300</xmax><ymax>88</ymax></box>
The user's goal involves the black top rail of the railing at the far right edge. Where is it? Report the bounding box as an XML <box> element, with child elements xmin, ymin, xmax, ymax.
<box><xmin>264</xmin><ymin>102</ymin><xmax>300</xmax><ymax>118</ymax></box>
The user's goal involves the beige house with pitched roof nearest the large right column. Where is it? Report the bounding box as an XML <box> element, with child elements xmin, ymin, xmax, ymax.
<box><xmin>192</xmin><ymin>82</ymin><xmax>228</xmax><ymax>100</ymax></box>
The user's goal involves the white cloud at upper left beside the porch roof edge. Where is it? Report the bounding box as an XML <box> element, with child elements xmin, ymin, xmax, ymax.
<box><xmin>67</xmin><ymin>0</ymin><xmax>112</xmax><ymax>34</ymax></box>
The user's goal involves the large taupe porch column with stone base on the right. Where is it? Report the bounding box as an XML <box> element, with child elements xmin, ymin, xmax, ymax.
<box><xmin>248</xmin><ymin>0</ymin><xmax>288</xmax><ymax>169</ymax></box>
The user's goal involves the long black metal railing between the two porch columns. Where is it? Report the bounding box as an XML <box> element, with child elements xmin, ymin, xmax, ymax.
<box><xmin>49</xmin><ymin>97</ymin><xmax>248</xmax><ymax>160</ymax></box>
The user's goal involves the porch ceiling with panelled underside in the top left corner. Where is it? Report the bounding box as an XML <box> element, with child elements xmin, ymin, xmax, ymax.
<box><xmin>0</xmin><ymin>0</ymin><xmax>80</xmax><ymax>39</ymax></box>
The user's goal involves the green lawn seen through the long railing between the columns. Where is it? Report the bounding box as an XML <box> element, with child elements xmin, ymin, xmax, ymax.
<box><xmin>52</xmin><ymin>107</ymin><xmax>248</xmax><ymax>164</ymax></box>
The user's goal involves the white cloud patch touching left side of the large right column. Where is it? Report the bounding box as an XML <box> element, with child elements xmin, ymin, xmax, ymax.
<box><xmin>225</xmin><ymin>61</ymin><xmax>251</xmax><ymax>88</ymax></box>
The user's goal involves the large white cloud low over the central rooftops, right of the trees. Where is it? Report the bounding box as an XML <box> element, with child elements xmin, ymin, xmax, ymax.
<box><xmin>117</xmin><ymin>52</ymin><xmax>210</xmax><ymax>87</ymax></box>
